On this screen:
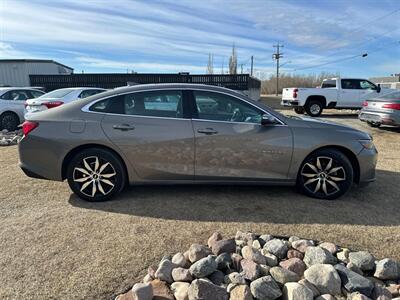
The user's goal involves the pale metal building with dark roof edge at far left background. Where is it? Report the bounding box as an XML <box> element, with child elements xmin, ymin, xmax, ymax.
<box><xmin>0</xmin><ymin>59</ymin><xmax>74</xmax><ymax>86</ymax></box>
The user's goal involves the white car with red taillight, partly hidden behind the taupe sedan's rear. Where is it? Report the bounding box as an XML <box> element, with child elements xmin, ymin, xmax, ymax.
<box><xmin>25</xmin><ymin>87</ymin><xmax>105</xmax><ymax>114</ymax></box>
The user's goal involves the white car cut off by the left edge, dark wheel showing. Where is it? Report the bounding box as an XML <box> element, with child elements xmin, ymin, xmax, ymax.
<box><xmin>0</xmin><ymin>87</ymin><xmax>44</xmax><ymax>131</ymax></box>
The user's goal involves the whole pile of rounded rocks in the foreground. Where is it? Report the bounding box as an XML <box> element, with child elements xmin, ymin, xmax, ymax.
<box><xmin>115</xmin><ymin>231</ymin><xmax>400</xmax><ymax>300</ymax></box>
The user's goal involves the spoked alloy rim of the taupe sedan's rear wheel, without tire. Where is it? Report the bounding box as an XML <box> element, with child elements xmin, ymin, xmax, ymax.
<box><xmin>72</xmin><ymin>156</ymin><xmax>117</xmax><ymax>198</ymax></box>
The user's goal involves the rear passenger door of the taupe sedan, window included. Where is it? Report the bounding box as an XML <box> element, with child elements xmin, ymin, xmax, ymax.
<box><xmin>92</xmin><ymin>90</ymin><xmax>194</xmax><ymax>180</ymax></box>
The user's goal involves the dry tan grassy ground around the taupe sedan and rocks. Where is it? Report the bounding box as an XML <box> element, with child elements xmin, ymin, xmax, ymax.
<box><xmin>0</xmin><ymin>99</ymin><xmax>400</xmax><ymax>299</ymax></box>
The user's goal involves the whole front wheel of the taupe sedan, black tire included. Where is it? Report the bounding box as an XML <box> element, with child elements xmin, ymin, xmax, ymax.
<box><xmin>297</xmin><ymin>149</ymin><xmax>354</xmax><ymax>200</ymax></box>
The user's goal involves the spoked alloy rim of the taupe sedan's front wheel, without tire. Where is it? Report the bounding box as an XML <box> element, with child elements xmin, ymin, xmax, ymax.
<box><xmin>300</xmin><ymin>156</ymin><xmax>346</xmax><ymax>196</ymax></box>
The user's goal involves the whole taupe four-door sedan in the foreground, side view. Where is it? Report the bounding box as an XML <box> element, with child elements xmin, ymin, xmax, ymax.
<box><xmin>19</xmin><ymin>84</ymin><xmax>377</xmax><ymax>201</ymax></box>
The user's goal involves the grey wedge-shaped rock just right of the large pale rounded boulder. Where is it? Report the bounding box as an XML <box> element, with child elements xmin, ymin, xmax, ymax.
<box><xmin>335</xmin><ymin>264</ymin><xmax>374</xmax><ymax>296</ymax></box>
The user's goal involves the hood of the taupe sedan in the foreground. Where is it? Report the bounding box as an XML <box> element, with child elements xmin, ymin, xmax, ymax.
<box><xmin>288</xmin><ymin>116</ymin><xmax>371</xmax><ymax>139</ymax></box>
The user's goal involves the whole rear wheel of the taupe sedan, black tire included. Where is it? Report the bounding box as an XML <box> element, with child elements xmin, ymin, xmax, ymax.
<box><xmin>67</xmin><ymin>148</ymin><xmax>127</xmax><ymax>202</ymax></box>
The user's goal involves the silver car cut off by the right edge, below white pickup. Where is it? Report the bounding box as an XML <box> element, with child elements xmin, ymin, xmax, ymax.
<box><xmin>359</xmin><ymin>90</ymin><xmax>400</xmax><ymax>127</ymax></box>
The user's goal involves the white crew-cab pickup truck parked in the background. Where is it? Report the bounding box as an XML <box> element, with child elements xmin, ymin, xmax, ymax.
<box><xmin>281</xmin><ymin>78</ymin><xmax>393</xmax><ymax>117</ymax></box>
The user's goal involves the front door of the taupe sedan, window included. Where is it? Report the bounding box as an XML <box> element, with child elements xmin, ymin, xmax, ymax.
<box><xmin>192</xmin><ymin>90</ymin><xmax>293</xmax><ymax>180</ymax></box>
